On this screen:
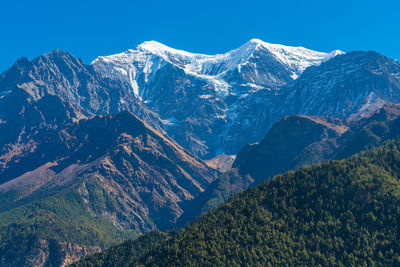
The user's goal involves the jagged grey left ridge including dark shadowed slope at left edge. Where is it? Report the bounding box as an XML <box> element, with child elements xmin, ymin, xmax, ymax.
<box><xmin>0</xmin><ymin>50</ymin><xmax>162</xmax><ymax>149</ymax></box>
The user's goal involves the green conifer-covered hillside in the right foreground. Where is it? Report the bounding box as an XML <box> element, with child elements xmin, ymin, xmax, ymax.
<box><xmin>73</xmin><ymin>139</ymin><xmax>400</xmax><ymax>266</ymax></box>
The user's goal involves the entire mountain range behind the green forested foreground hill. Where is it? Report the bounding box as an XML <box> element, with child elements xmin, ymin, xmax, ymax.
<box><xmin>0</xmin><ymin>39</ymin><xmax>400</xmax><ymax>266</ymax></box>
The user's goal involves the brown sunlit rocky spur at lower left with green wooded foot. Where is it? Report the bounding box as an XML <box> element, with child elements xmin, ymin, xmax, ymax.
<box><xmin>0</xmin><ymin>109</ymin><xmax>217</xmax><ymax>266</ymax></box>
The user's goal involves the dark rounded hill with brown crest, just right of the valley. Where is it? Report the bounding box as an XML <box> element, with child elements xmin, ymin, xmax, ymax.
<box><xmin>234</xmin><ymin>115</ymin><xmax>348</xmax><ymax>181</ymax></box>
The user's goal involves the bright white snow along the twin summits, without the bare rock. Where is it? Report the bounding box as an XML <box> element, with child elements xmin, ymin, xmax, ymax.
<box><xmin>91</xmin><ymin>39</ymin><xmax>343</xmax><ymax>101</ymax></box>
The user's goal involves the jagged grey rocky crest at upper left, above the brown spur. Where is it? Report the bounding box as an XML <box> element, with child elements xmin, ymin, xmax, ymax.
<box><xmin>0</xmin><ymin>50</ymin><xmax>162</xmax><ymax>129</ymax></box>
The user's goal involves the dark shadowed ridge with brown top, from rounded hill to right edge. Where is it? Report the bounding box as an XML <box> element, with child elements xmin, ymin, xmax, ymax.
<box><xmin>233</xmin><ymin>103</ymin><xmax>400</xmax><ymax>182</ymax></box>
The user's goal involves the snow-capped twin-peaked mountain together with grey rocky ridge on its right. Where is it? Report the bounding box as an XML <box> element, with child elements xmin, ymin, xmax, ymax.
<box><xmin>92</xmin><ymin>43</ymin><xmax>400</xmax><ymax>159</ymax></box>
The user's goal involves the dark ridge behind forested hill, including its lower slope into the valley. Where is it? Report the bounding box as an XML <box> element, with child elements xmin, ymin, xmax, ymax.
<box><xmin>178</xmin><ymin>104</ymin><xmax>400</xmax><ymax>226</ymax></box>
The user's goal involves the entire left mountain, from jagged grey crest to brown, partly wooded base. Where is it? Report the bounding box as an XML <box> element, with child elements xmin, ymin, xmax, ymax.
<box><xmin>0</xmin><ymin>50</ymin><xmax>217</xmax><ymax>266</ymax></box>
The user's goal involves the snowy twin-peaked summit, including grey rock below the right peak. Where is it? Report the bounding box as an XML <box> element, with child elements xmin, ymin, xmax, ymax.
<box><xmin>92</xmin><ymin>39</ymin><xmax>343</xmax><ymax>97</ymax></box>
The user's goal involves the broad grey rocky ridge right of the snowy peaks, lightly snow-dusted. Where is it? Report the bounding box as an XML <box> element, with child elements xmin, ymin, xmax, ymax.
<box><xmin>281</xmin><ymin>51</ymin><xmax>400</xmax><ymax>119</ymax></box>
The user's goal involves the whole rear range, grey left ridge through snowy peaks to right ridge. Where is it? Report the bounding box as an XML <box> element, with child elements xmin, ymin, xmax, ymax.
<box><xmin>0</xmin><ymin>43</ymin><xmax>400</xmax><ymax>159</ymax></box>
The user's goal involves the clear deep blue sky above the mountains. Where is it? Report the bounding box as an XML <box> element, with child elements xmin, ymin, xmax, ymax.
<box><xmin>0</xmin><ymin>0</ymin><xmax>400</xmax><ymax>73</ymax></box>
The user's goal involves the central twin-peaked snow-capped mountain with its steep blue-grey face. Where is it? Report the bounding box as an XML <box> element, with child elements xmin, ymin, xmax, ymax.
<box><xmin>92</xmin><ymin>39</ymin><xmax>343</xmax><ymax>158</ymax></box>
